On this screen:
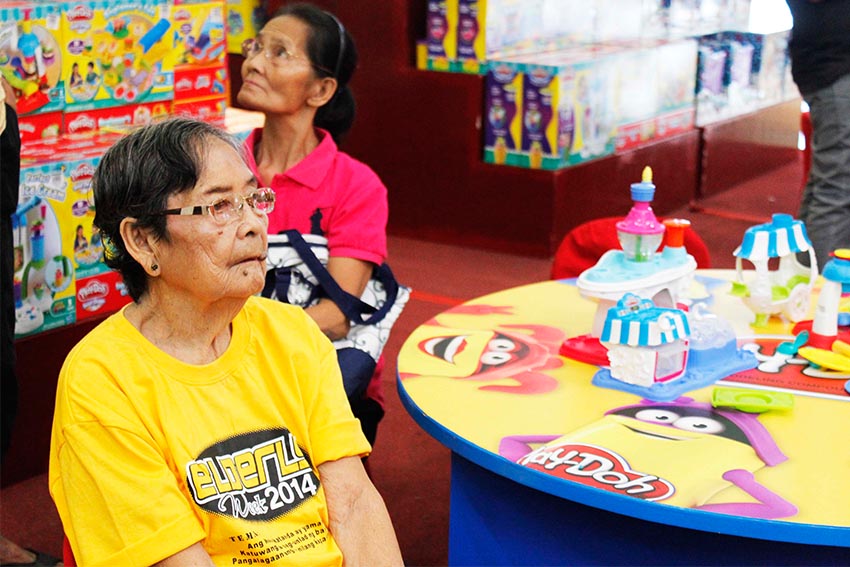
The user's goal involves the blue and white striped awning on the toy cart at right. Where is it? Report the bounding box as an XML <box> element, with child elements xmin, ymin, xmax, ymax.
<box><xmin>734</xmin><ymin>213</ymin><xmax>812</xmax><ymax>262</ymax></box>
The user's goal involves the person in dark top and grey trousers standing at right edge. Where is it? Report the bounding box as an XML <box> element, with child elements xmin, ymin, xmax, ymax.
<box><xmin>786</xmin><ymin>0</ymin><xmax>850</xmax><ymax>266</ymax></box>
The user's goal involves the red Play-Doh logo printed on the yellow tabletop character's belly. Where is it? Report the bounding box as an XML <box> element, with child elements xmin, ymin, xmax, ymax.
<box><xmin>519</xmin><ymin>443</ymin><xmax>675</xmax><ymax>501</ymax></box>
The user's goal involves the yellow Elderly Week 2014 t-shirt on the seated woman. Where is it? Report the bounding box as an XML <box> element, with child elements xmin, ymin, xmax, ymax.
<box><xmin>49</xmin><ymin>297</ymin><xmax>369</xmax><ymax>565</ymax></box>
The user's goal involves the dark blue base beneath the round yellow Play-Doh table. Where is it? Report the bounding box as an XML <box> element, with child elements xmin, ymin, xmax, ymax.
<box><xmin>449</xmin><ymin>452</ymin><xmax>850</xmax><ymax>566</ymax></box>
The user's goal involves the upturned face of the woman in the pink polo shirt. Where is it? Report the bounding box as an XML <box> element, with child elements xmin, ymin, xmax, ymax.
<box><xmin>237</xmin><ymin>16</ymin><xmax>318</xmax><ymax>114</ymax></box>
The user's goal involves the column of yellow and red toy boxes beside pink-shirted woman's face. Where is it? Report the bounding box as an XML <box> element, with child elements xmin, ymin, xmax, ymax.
<box><xmin>171</xmin><ymin>0</ymin><xmax>229</xmax><ymax>122</ymax></box>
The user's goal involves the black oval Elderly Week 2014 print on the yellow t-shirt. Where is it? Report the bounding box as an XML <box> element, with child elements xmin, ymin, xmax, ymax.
<box><xmin>186</xmin><ymin>428</ymin><xmax>320</xmax><ymax>522</ymax></box>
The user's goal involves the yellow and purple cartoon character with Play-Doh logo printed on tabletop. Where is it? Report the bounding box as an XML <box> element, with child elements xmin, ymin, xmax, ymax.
<box><xmin>499</xmin><ymin>397</ymin><xmax>797</xmax><ymax>519</ymax></box>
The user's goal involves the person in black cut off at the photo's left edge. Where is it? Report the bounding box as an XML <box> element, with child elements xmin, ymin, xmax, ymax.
<box><xmin>0</xmin><ymin>77</ymin><xmax>59</xmax><ymax>566</ymax></box>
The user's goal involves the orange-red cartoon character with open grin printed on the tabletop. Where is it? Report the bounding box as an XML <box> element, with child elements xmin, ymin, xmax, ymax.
<box><xmin>399</xmin><ymin>305</ymin><xmax>565</xmax><ymax>394</ymax></box>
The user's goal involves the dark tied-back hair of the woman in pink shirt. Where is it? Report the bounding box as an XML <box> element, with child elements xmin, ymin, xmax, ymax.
<box><xmin>272</xmin><ymin>2</ymin><xmax>357</xmax><ymax>142</ymax></box>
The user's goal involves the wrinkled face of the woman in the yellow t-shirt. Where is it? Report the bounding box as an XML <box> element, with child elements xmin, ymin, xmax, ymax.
<box><xmin>156</xmin><ymin>139</ymin><xmax>268</xmax><ymax>303</ymax></box>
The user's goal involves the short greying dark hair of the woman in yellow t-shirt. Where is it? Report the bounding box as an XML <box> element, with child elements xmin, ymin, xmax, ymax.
<box><xmin>92</xmin><ymin>118</ymin><xmax>241</xmax><ymax>302</ymax></box>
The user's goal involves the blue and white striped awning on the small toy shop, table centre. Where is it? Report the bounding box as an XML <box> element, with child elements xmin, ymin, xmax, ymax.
<box><xmin>600</xmin><ymin>293</ymin><xmax>691</xmax><ymax>347</ymax></box>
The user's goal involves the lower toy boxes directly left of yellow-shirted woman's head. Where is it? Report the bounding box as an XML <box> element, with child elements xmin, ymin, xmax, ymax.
<box><xmin>12</xmin><ymin>134</ymin><xmax>129</xmax><ymax>336</ymax></box>
